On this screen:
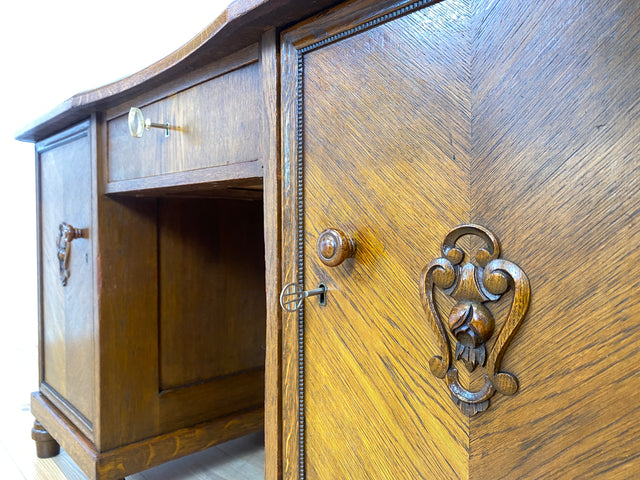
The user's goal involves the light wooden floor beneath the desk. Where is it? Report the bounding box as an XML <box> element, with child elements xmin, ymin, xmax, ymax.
<box><xmin>0</xmin><ymin>324</ymin><xmax>264</xmax><ymax>480</ymax></box>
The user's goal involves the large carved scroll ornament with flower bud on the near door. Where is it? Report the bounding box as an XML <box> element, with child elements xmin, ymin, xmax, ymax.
<box><xmin>420</xmin><ymin>225</ymin><xmax>530</xmax><ymax>416</ymax></box>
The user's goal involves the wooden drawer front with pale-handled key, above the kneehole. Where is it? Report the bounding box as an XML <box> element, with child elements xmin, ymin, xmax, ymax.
<box><xmin>107</xmin><ymin>62</ymin><xmax>262</xmax><ymax>182</ymax></box>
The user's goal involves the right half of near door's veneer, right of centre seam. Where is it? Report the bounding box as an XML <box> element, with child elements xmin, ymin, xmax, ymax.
<box><xmin>470</xmin><ymin>0</ymin><xmax>640</xmax><ymax>479</ymax></box>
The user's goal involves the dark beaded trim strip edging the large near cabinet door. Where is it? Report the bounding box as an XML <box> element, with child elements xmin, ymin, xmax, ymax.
<box><xmin>296</xmin><ymin>0</ymin><xmax>438</xmax><ymax>480</ymax></box>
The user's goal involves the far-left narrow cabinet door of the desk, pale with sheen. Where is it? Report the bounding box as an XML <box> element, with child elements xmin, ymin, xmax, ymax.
<box><xmin>37</xmin><ymin>124</ymin><xmax>95</xmax><ymax>434</ymax></box>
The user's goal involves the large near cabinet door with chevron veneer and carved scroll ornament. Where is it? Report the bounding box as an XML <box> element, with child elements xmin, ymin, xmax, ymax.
<box><xmin>282</xmin><ymin>0</ymin><xmax>640</xmax><ymax>479</ymax></box>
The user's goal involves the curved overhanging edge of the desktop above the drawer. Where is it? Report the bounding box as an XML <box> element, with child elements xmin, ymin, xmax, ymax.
<box><xmin>16</xmin><ymin>0</ymin><xmax>338</xmax><ymax>142</ymax></box>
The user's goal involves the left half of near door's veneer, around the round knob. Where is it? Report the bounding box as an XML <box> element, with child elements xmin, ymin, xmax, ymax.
<box><xmin>283</xmin><ymin>2</ymin><xmax>470</xmax><ymax>478</ymax></box>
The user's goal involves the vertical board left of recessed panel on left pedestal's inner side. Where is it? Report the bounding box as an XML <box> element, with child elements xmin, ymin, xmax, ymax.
<box><xmin>96</xmin><ymin>196</ymin><xmax>158</xmax><ymax>451</ymax></box>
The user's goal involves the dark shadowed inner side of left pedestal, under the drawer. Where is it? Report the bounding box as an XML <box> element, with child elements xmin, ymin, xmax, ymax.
<box><xmin>94</xmin><ymin>192</ymin><xmax>265</xmax><ymax>451</ymax></box>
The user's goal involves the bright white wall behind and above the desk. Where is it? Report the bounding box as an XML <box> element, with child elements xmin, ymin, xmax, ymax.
<box><xmin>0</xmin><ymin>0</ymin><xmax>230</xmax><ymax>392</ymax></box>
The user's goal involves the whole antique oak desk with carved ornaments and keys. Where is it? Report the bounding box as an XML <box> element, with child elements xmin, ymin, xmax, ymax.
<box><xmin>20</xmin><ymin>0</ymin><xmax>640</xmax><ymax>479</ymax></box>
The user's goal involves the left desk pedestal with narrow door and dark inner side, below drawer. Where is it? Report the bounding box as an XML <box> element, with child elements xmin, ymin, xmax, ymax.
<box><xmin>32</xmin><ymin>87</ymin><xmax>265</xmax><ymax>479</ymax></box>
